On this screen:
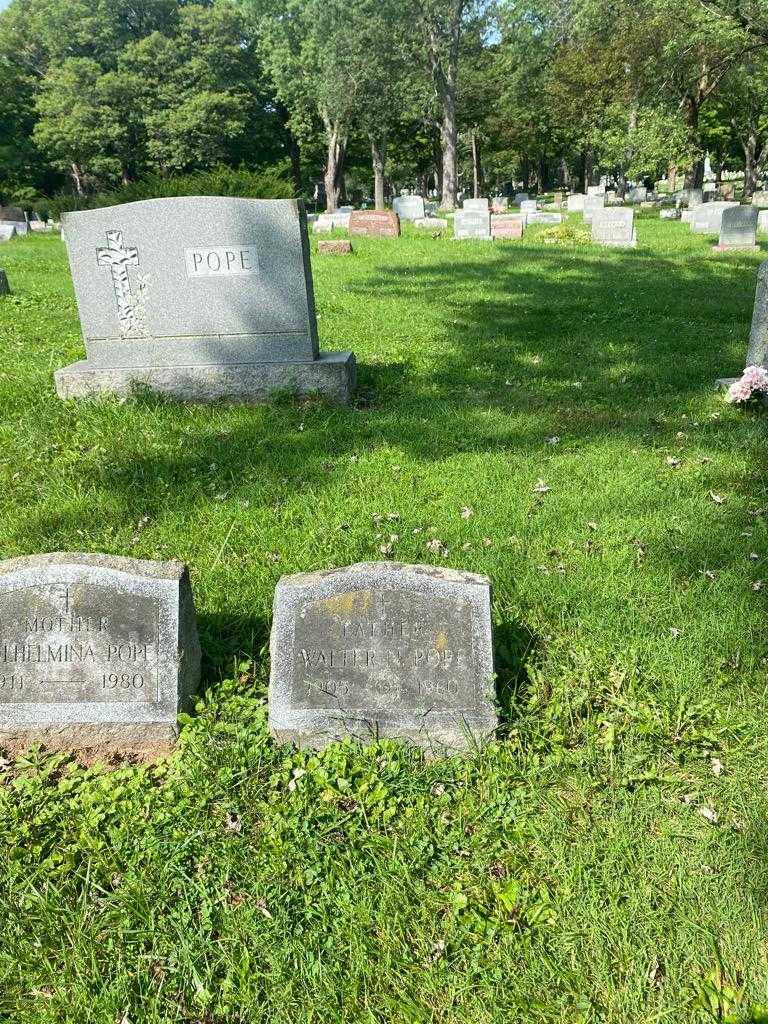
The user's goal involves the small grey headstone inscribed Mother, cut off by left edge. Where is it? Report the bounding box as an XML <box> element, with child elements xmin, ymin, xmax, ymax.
<box><xmin>0</xmin><ymin>553</ymin><xmax>201</xmax><ymax>750</ymax></box>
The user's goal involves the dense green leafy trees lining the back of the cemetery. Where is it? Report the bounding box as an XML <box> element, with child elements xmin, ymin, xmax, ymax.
<box><xmin>0</xmin><ymin>0</ymin><xmax>768</xmax><ymax>207</ymax></box>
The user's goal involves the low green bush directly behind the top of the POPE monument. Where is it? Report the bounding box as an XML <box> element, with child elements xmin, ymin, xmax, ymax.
<box><xmin>40</xmin><ymin>164</ymin><xmax>294</xmax><ymax>218</ymax></box>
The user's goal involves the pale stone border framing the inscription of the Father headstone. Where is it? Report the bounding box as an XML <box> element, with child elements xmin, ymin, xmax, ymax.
<box><xmin>268</xmin><ymin>561</ymin><xmax>499</xmax><ymax>756</ymax></box>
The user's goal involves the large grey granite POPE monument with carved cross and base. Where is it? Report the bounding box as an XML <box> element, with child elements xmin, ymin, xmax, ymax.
<box><xmin>55</xmin><ymin>197</ymin><xmax>355</xmax><ymax>401</ymax></box>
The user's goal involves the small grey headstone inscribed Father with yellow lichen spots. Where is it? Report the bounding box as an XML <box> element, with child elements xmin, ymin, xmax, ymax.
<box><xmin>269</xmin><ymin>562</ymin><xmax>498</xmax><ymax>755</ymax></box>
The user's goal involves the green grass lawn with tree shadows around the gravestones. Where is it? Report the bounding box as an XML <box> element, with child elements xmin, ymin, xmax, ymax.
<box><xmin>0</xmin><ymin>214</ymin><xmax>768</xmax><ymax>1024</ymax></box>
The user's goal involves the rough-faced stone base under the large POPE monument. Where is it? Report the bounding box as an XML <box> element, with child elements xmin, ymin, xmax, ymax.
<box><xmin>53</xmin><ymin>351</ymin><xmax>357</xmax><ymax>404</ymax></box>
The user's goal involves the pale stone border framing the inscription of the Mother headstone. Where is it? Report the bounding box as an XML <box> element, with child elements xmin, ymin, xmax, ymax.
<box><xmin>0</xmin><ymin>551</ymin><xmax>202</xmax><ymax>757</ymax></box>
